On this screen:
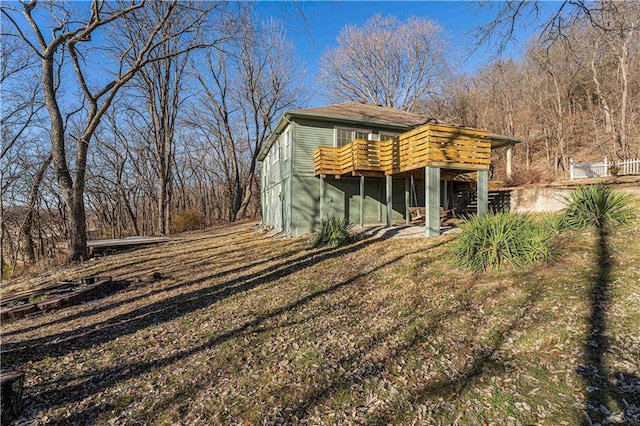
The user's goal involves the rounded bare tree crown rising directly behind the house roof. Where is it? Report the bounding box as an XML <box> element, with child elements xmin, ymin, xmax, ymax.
<box><xmin>319</xmin><ymin>15</ymin><xmax>451</xmax><ymax>110</ymax></box>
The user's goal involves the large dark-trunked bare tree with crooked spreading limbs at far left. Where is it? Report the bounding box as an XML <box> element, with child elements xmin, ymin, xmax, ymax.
<box><xmin>0</xmin><ymin>0</ymin><xmax>214</xmax><ymax>260</ymax></box>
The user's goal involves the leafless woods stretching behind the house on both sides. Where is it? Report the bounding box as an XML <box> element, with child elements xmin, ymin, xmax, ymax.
<box><xmin>0</xmin><ymin>1</ymin><xmax>640</xmax><ymax>269</ymax></box>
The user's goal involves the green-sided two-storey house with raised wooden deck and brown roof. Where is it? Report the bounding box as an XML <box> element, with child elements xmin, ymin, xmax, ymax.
<box><xmin>258</xmin><ymin>102</ymin><xmax>520</xmax><ymax>236</ymax></box>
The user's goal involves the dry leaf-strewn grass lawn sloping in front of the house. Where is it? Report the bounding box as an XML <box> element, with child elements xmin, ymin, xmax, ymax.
<box><xmin>2</xmin><ymin>218</ymin><xmax>640</xmax><ymax>425</ymax></box>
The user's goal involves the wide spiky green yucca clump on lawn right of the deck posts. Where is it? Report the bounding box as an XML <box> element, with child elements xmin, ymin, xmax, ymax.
<box><xmin>451</xmin><ymin>212</ymin><xmax>555</xmax><ymax>272</ymax></box>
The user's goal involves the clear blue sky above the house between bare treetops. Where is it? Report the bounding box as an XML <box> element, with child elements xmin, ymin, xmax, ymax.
<box><xmin>255</xmin><ymin>1</ymin><xmax>558</xmax><ymax>106</ymax></box>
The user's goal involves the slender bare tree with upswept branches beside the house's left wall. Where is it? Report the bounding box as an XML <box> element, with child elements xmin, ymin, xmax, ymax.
<box><xmin>189</xmin><ymin>9</ymin><xmax>306</xmax><ymax>221</ymax></box>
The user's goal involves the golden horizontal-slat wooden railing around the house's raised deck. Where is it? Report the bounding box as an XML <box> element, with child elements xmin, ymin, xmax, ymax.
<box><xmin>314</xmin><ymin>124</ymin><xmax>491</xmax><ymax>175</ymax></box>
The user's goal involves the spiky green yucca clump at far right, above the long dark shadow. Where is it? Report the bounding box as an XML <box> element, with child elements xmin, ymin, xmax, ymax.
<box><xmin>562</xmin><ymin>185</ymin><xmax>633</xmax><ymax>229</ymax></box>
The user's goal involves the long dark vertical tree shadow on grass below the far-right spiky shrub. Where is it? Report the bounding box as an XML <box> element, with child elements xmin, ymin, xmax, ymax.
<box><xmin>577</xmin><ymin>224</ymin><xmax>640</xmax><ymax>426</ymax></box>
